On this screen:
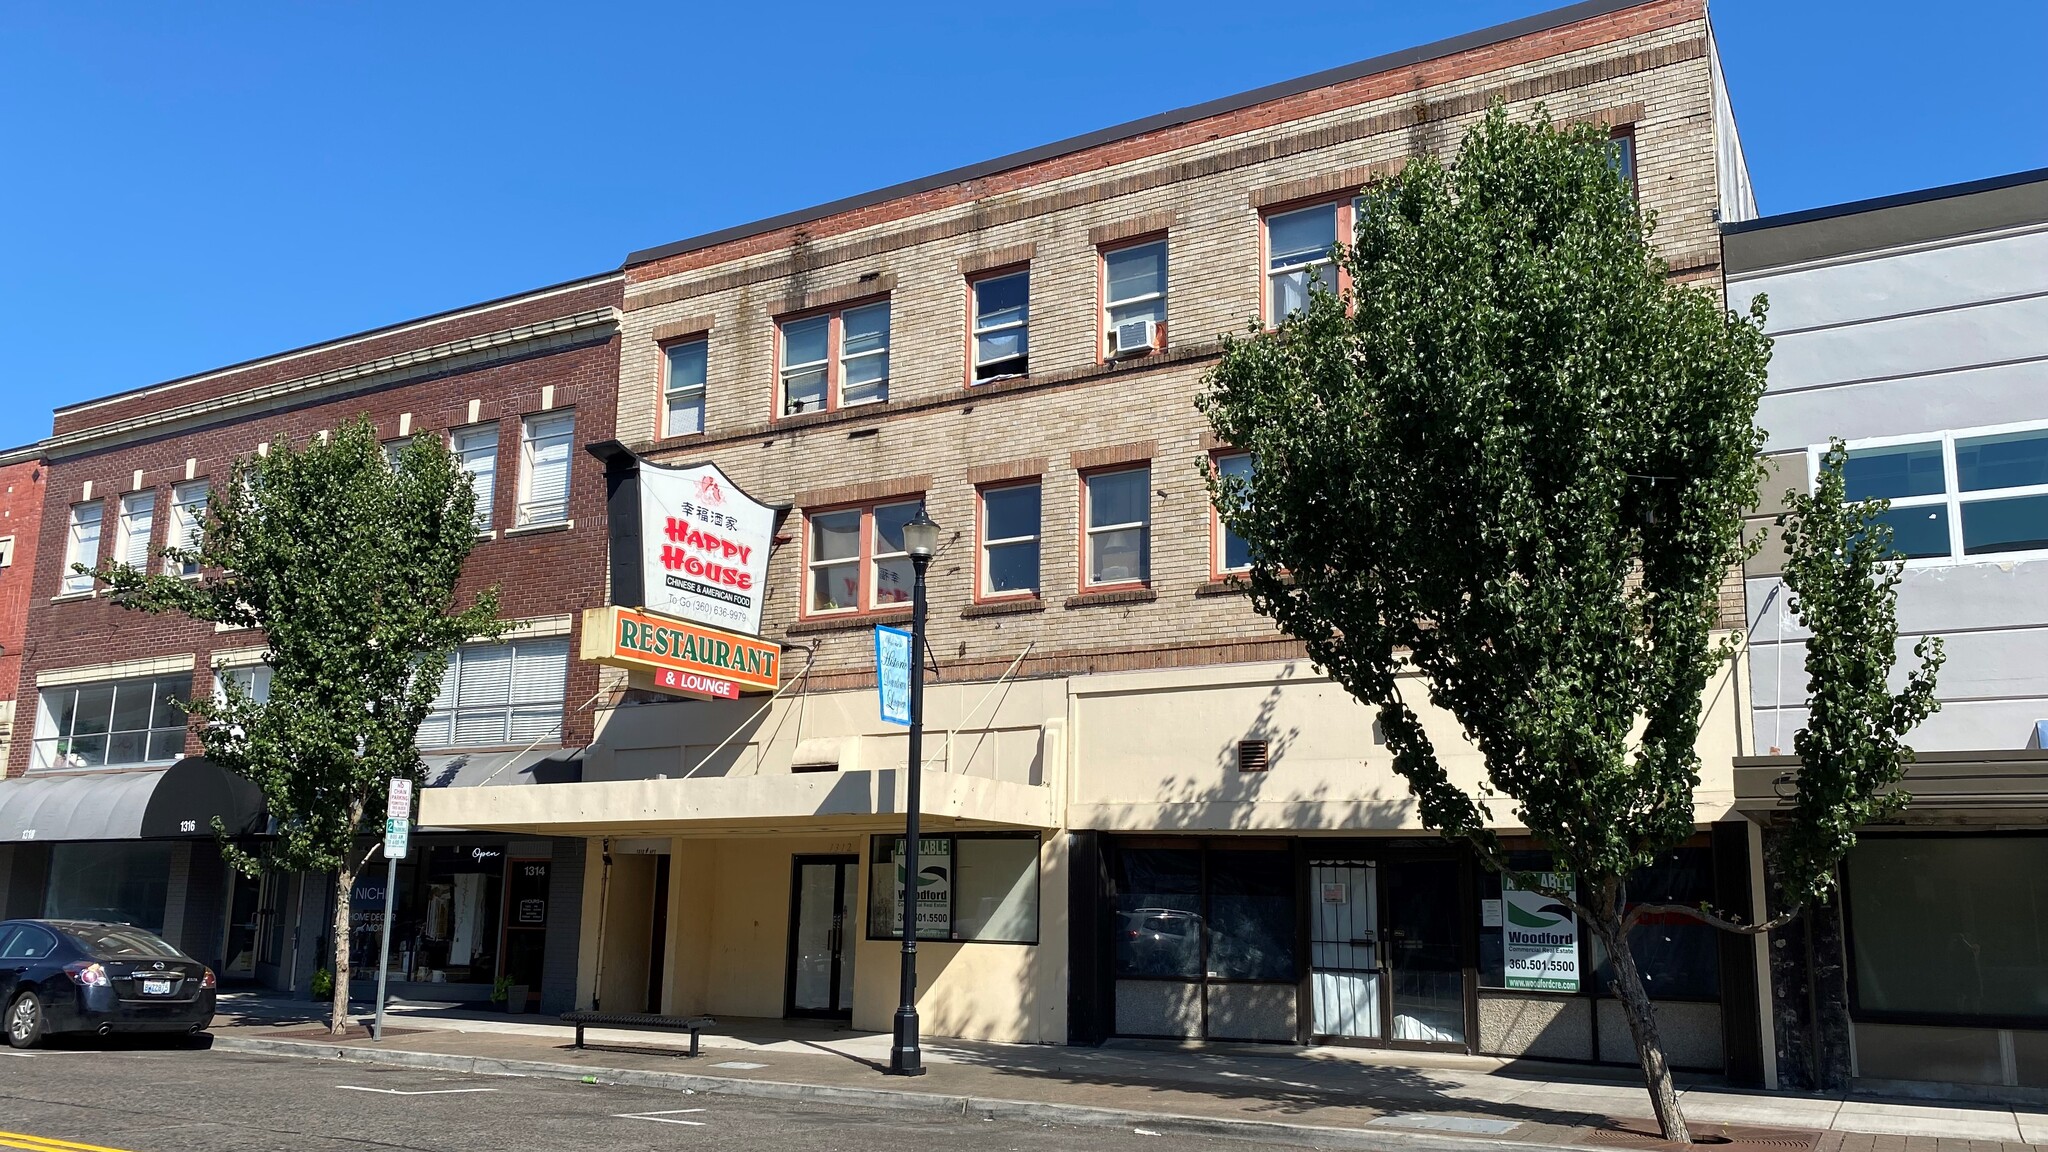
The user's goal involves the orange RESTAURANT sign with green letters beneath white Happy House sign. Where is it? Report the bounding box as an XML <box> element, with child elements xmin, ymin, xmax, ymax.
<box><xmin>584</xmin><ymin>605</ymin><xmax>782</xmax><ymax>699</ymax></box>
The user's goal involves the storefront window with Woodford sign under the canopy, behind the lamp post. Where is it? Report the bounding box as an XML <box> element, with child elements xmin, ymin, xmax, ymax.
<box><xmin>868</xmin><ymin>834</ymin><xmax>1038</xmax><ymax>945</ymax></box>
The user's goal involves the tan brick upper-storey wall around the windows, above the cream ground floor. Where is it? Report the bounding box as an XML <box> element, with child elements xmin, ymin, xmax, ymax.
<box><xmin>618</xmin><ymin>0</ymin><xmax>1739</xmax><ymax>687</ymax></box>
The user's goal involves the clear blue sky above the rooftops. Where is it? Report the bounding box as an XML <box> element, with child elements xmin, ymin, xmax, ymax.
<box><xmin>0</xmin><ymin>0</ymin><xmax>2048</xmax><ymax>445</ymax></box>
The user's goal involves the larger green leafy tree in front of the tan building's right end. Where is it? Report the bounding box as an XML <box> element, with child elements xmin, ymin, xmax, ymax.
<box><xmin>1198</xmin><ymin>107</ymin><xmax>1933</xmax><ymax>1140</ymax></box>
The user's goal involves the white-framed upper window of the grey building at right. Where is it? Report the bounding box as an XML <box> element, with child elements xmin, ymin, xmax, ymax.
<box><xmin>1835</xmin><ymin>426</ymin><xmax>2048</xmax><ymax>560</ymax></box>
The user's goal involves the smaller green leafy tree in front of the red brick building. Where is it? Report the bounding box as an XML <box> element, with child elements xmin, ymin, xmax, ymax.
<box><xmin>96</xmin><ymin>420</ymin><xmax>504</xmax><ymax>1033</ymax></box>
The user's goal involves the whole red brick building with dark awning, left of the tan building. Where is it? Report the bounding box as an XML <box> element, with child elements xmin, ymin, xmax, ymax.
<box><xmin>0</xmin><ymin>275</ymin><xmax>621</xmax><ymax>996</ymax></box>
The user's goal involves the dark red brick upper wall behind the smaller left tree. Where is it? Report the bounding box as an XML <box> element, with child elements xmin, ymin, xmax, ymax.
<box><xmin>0</xmin><ymin>277</ymin><xmax>621</xmax><ymax>775</ymax></box>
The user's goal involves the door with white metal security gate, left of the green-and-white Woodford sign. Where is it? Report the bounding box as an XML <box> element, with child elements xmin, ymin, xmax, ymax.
<box><xmin>1309</xmin><ymin>861</ymin><xmax>1386</xmax><ymax>1039</ymax></box>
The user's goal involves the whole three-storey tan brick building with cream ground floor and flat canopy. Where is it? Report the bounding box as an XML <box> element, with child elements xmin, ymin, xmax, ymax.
<box><xmin>430</xmin><ymin>0</ymin><xmax>1755</xmax><ymax>1076</ymax></box>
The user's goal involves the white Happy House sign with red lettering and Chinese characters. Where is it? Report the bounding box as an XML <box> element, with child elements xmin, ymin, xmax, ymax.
<box><xmin>639</xmin><ymin>461</ymin><xmax>776</xmax><ymax>635</ymax></box>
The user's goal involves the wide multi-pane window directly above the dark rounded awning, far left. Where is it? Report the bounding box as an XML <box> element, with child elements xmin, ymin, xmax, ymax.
<box><xmin>35</xmin><ymin>672</ymin><xmax>193</xmax><ymax>769</ymax></box>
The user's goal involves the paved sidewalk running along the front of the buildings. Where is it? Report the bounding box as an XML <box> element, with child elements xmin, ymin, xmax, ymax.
<box><xmin>213</xmin><ymin>994</ymin><xmax>2048</xmax><ymax>1152</ymax></box>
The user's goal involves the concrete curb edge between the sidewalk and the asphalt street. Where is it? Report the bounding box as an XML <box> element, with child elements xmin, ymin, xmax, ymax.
<box><xmin>213</xmin><ymin>1035</ymin><xmax>1597</xmax><ymax>1152</ymax></box>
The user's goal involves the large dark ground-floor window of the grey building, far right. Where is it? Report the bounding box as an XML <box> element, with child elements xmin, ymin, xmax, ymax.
<box><xmin>1847</xmin><ymin>834</ymin><xmax>2048</xmax><ymax>1023</ymax></box>
